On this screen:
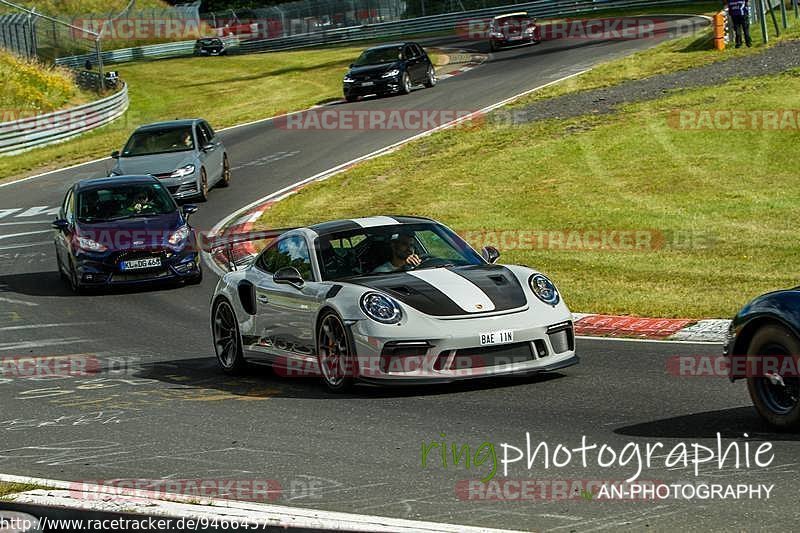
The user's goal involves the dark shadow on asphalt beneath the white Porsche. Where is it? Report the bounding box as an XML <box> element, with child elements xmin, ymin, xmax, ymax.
<box><xmin>132</xmin><ymin>357</ymin><xmax>566</xmax><ymax>400</ymax></box>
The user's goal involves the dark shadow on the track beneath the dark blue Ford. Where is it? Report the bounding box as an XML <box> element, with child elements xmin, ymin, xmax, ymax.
<box><xmin>0</xmin><ymin>271</ymin><xmax>195</xmax><ymax>298</ymax></box>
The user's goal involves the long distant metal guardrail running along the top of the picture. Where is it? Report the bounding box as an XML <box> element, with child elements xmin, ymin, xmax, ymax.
<box><xmin>56</xmin><ymin>0</ymin><xmax>694</xmax><ymax>68</ymax></box>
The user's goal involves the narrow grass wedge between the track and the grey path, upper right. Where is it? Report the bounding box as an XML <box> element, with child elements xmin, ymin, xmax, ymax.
<box><xmin>514</xmin><ymin>7</ymin><xmax>800</xmax><ymax>103</ymax></box>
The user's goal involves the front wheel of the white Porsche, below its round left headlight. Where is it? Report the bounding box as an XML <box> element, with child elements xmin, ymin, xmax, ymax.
<box><xmin>317</xmin><ymin>311</ymin><xmax>355</xmax><ymax>392</ymax></box>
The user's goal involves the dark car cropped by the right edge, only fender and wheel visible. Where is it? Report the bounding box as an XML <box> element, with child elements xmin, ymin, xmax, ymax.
<box><xmin>724</xmin><ymin>287</ymin><xmax>800</xmax><ymax>430</ymax></box>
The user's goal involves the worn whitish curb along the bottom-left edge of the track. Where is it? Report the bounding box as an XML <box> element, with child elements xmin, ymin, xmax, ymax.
<box><xmin>0</xmin><ymin>474</ymin><xmax>511</xmax><ymax>533</ymax></box>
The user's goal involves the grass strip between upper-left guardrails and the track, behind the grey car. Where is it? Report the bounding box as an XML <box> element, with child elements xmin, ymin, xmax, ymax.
<box><xmin>0</xmin><ymin>47</ymin><xmax>368</xmax><ymax>180</ymax></box>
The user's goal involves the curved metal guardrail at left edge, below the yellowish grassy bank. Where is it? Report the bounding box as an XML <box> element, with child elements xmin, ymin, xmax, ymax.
<box><xmin>0</xmin><ymin>85</ymin><xmax>128</xmax><ymax>155</ymax></box>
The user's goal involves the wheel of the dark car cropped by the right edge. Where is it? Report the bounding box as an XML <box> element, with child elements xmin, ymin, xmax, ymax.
<box><xmin>747</xmin><ymin>325</ymin><xmax>800</xmax><ymax>430</ymax></box>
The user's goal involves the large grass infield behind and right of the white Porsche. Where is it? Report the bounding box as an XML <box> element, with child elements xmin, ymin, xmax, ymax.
<box><xmin>259</xmin><ymin>71</ymin><xmax>800</xmax><ymax>318</ymax></box>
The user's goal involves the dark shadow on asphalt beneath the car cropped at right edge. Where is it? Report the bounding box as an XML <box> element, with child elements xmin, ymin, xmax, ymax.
<box><xmin>614</xmin><ymin>407</ymin><xmax>800</xmax><ymax>441</ymax></box>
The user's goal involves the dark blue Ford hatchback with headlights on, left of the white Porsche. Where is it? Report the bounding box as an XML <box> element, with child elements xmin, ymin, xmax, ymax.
<box><xmin>53</xmin><ymin>176</ymin><xmax>203</xmax><ymax>293</ymax></box>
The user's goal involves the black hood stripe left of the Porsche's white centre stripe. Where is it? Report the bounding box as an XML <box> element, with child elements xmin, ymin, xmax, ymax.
<box><xmin>347</xmin><ymin>272</ymin><xmax>462</xmax><ymax>316</ymax></box>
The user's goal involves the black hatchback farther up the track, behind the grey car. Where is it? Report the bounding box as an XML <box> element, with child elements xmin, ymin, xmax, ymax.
<box><xmin>343</xmin><ymin>42</ymin><xmax>436</xmax><ymax>102</ymax></box>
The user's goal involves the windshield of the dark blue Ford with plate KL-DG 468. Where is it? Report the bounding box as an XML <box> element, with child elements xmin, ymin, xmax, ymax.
<box><xmin>77</xmin><ymin>183</ymin><xmax>177</xmax><ymax>223</ymax></box>
